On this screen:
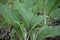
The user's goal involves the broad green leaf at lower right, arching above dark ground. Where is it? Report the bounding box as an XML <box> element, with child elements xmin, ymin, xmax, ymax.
<box><xmin>37</xmin><ymin>26</ymin><xmax>60</xmax><ymax>40</ymax></box>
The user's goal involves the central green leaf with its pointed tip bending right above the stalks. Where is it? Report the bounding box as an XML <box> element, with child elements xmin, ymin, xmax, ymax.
<box><xmin>30</xmin><ymin>15</ymin><xmax>47</xmax><ymax>31</ymax></box>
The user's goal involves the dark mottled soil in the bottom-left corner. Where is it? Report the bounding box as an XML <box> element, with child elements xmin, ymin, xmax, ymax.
<box><xmin>0</xmin><ymin>26</ymin><xmax>12</xmax><ymax>40</ymax></box>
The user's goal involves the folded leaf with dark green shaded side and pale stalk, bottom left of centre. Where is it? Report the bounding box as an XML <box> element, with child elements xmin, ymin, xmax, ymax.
<box><xmin>13</xmin><ymin>22</ymin><xmax>27</xmax><ymax>40</ymax></box>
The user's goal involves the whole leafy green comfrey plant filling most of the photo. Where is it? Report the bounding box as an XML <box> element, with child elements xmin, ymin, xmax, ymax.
<box><xmin>0</xmin><ymin>0</ymin><xmax>60</xmax><ymax>40</ymax></box>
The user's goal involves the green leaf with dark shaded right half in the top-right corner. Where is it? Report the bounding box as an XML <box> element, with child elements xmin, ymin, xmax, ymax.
<box><xmin>46</xmin><ymin>0</ymin><xmax>60</xmax><ymax>13</ymax></box>
